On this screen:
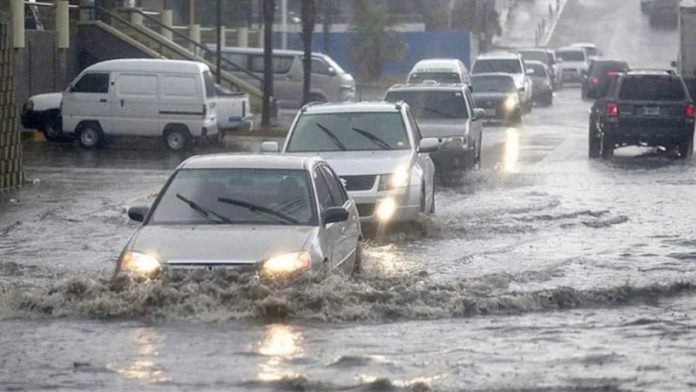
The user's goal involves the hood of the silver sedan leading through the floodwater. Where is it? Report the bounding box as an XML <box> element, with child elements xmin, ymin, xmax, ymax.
<box><xmin>130</xmin><ymin>225</ymin><xmax>318</xmax><ymax>265</ymax></box>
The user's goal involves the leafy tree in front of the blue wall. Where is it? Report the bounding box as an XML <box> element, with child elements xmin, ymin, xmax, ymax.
<box><xmin>348</xmin><ymin>0</ymin><xmax>405</xmax><ymax>80</ymax></box>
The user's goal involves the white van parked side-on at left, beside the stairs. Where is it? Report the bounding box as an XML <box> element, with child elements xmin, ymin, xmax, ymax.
<box><xmin>61</xmin><ymin>59</ymin><xmax>218</xmax><ymax>151</ymax></box>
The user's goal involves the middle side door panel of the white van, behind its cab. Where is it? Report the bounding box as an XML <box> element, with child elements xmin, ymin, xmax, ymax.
<box><xmin>111</xmin><ymin>72</ymin><xmax>162</xmax><ymax>136</ymax></box>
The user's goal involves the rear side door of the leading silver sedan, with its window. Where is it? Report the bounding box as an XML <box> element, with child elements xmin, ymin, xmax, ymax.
<box><xmin>320</xmin><ymin>165</ymin><xmax>360</xmax><ymax>263</ymax></box>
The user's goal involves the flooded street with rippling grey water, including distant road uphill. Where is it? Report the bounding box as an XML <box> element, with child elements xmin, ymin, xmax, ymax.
<box><xmin>0</xmin><ymin>0</ymin><xmax>696</xmax><ymax>391</ymax></box>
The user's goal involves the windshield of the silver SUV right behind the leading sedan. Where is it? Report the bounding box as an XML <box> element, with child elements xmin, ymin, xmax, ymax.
<box><xmin>287</xmin><ymin>112</ymin><xmax>410</xmax><ymax>152</ymax></box>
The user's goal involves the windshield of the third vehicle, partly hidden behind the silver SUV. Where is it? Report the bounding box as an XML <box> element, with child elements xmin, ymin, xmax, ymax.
<box><xmin>385</xmin><ymin>90</ymin><xmax>469</xmax><ymax>120</ymax></box>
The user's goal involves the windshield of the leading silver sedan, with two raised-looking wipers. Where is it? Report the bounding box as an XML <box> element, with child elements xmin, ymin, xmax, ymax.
<box><xmin>150</xmin><ymin>169</ymin><xmax>316</xmax><ymax>225</ymax></box>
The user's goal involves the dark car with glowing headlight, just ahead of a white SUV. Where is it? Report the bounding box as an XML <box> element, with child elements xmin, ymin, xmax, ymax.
<box><xmin>471</xmin><ymin>73</ymin><xmax>522</xmax><ymax>124</ymax></box>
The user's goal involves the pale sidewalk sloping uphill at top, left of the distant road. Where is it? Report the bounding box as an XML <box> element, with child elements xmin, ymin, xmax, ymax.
<box><xmin>497</xmin><ymin>0</ymin><xmax>567</xmax><ymax>47</ymax></box>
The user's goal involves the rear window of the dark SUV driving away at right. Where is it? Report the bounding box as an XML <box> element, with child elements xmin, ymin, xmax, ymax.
<box><xmin>619</xmin><ymin>75</ymin><xmax>686</xmax><ymax>101</ymax></box>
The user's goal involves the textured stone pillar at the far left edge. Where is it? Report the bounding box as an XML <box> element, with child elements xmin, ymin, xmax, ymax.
<box><xmin>0</xmin><ymin>12</ymin><xmax>24</xmax><ymax>190</ymax></box>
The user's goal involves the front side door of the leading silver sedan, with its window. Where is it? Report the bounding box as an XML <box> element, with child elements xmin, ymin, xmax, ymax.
<box><xmin>312</xmin><ymin>166</ymin><xmax>343</xmax><ymax>269</ymax></box>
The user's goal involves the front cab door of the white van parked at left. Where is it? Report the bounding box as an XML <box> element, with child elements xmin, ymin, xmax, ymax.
<box><xmin>61</xmin><ymin>72</ymin><xmax>112</xmax><ymax>133</ymax></box>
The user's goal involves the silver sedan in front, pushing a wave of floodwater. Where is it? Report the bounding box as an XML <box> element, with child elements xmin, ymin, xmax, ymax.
<box><xmin>117</xmin><ymin>155</ymin><xmax>361</xmax><ymax>278</ymax></box>
